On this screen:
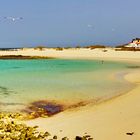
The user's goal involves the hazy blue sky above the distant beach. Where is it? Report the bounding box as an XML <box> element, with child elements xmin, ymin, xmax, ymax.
<box><xmin>0</xmin><ymin>0</ymin><xmax>140</xmax><ymax>48</ymax></box>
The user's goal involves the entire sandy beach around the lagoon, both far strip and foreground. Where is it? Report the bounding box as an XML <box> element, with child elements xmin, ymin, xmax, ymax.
<box><xmin>0</xmin><ymin>49</ymin><xmax>140</xmax><ymax>140</ymax></box>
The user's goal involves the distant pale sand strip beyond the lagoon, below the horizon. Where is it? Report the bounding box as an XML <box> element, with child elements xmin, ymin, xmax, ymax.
<box><xmin>0</xmin><ymin>48</ymin><xmax>140</xmax><ymax>62</ymax></box>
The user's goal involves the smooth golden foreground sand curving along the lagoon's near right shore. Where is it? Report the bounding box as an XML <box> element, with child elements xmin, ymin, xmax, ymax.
<box><xmin>25</xmin><ymin>68</ymin><xmax>140</xmax><ymax>140</ymax></box>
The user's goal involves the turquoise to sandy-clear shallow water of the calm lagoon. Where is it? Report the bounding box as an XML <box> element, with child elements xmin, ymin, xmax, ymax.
<box><xmin>0</xmin><ymin>59</ymin><xmax>136</xmax><ymax>110</ymax></box>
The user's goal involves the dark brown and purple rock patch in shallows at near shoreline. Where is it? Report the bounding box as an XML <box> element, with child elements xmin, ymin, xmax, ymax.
<box><xmin>22</xmin><ymin>100</ymin><xmax>89</xmax><ymax>119</ymax></box>
